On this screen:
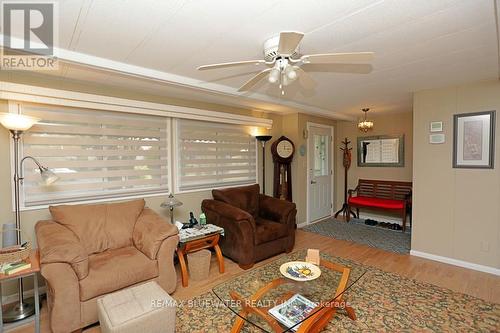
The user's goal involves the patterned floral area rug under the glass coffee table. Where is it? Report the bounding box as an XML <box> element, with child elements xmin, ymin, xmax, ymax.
<box><xmin>176</xmin><ymin>251</ymin><xmax>500</xmax><ymax>333</ymax></box>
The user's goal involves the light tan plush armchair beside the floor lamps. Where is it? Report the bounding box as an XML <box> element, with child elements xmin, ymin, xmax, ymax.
<box><xmin>35</xmin><ymin>200</ymin><xmax>179</xmax><ymax>333</ymax></box>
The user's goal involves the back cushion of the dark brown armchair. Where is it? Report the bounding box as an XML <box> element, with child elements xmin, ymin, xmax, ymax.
<box><xmin>212</xmin><ymin>184</ymin><xmax>260</xmax><ymax>218</ymax></box>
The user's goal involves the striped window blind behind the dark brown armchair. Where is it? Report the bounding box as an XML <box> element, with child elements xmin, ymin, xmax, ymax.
<box><xmin>176</xmin><ymin>119</ymin><xmax>257</xmax><ymax>191</ymax></box>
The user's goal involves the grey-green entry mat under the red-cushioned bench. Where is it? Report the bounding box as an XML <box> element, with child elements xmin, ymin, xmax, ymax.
<box><xmin>302</xmin><ymin>219</ymin><xmax>411</xmax><ymax>254</ymax></box>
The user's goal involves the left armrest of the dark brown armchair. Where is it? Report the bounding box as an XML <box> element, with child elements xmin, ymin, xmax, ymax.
<box><xmin>201</xmin><ymin>199</ymin><xmax>256</xmax><ymax>233</ymax></box>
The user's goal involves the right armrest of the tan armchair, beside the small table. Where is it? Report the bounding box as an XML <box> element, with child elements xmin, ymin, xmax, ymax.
<box><xmin>132</xmin><ymin>208</ymin><xmax>179</xmax><ymax>260</ymax></box>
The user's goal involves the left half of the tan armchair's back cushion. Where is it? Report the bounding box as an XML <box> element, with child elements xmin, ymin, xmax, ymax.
<box><xmin>49</xmin><ymin>204</ymin><xmax>108</xmax><ymax>254</ymax></box>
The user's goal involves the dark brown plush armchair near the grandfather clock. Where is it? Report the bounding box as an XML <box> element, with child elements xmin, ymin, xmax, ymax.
<box><xmin>202</xmin><ymin>185</ymin><xmax>297</xmax><ymax>269</ymax></box>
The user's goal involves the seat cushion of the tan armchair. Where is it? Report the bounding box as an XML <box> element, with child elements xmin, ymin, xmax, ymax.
<box><xmin>79</xmin><ymin>246</ymin><xmax>158</xmax><ymax>301</ymax></box>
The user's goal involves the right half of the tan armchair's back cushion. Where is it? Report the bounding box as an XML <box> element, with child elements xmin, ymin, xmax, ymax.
<box><xmin>106</xmin><ymin>199</ymin><xmax>145</xmax><ymax>249</ymax></box>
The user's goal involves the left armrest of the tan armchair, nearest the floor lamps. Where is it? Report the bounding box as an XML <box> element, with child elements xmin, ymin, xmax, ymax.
<box><xmin>35</xmin><ymin>221</ymin><xmax>89</xmax><ymax>280</ymax></box>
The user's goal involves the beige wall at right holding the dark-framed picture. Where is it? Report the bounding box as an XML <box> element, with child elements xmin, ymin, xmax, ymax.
<box><xmin>412</xmin><ymin>81</ymin><xmax>500</xmax><ymax>268</ymax></box>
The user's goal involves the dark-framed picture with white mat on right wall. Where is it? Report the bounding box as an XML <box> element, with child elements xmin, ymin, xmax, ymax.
<box><xmin>453</xmin><ymin>111</ymin><xmax>496</xmax><ymax>169</ymax></box>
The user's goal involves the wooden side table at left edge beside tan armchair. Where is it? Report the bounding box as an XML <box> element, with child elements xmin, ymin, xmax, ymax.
<box><xmin>0</xmin><ymin>250</ymin><xmax>40</xmax><ymax>333</ymax></box>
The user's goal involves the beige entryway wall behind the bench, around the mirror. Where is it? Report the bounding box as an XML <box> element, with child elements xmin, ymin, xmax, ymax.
<box><xmin>335</xmin><ymin>112</ymin><xmax>413</xmax><ymax>216</ymax></box>
